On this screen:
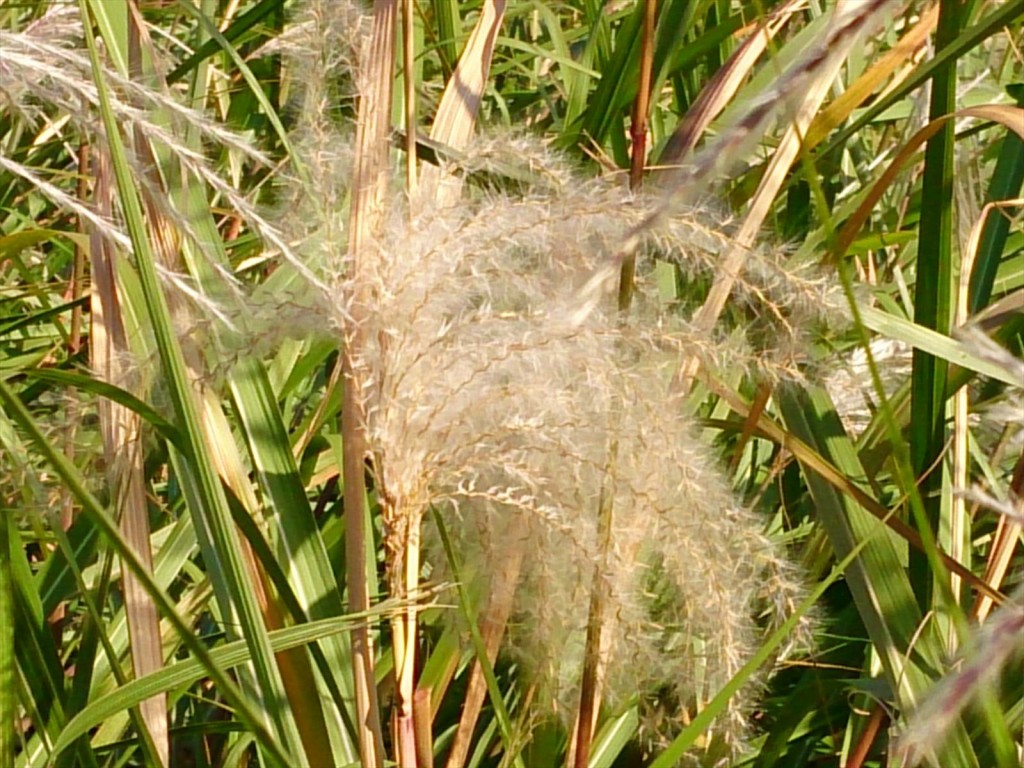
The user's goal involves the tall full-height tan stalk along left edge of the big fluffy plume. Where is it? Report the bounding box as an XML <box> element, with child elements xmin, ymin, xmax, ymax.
<box><xmin>341</xmin><ymin>0</ymin><xmax>395</xmax><ymax>768</ymax></box>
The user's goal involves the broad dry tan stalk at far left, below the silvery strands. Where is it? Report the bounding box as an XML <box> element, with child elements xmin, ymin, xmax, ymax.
<box><xmin>89</xmin><ymin>151</ymin><xmax>170</xmax><ymax>766</ymax></box>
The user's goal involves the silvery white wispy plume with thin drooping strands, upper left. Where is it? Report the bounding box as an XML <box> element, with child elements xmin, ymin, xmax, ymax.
<box><xmin>0</xmin><ymin>6</ymin><xmax>330</xmax><ymax>354</ymax></box>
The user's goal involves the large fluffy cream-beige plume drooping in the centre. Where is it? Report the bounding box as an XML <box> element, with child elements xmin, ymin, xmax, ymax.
<box><xmin>307</xmin><ymin>134</ymin><xmax>824</xmax><ymax>756</ymax></box>
